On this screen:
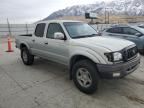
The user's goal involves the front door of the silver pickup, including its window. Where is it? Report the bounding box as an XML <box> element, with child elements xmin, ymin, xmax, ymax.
<box><xmin>45</xmin><ymin>23</ymin><xmax>69</xmax><ymax>64</ymax></box>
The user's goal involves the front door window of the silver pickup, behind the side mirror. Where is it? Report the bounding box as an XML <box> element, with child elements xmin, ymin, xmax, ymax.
<box><xmin>46</xmin><ymin>23</ymin><xmax>64</xmax><ymax>39</ymax></box>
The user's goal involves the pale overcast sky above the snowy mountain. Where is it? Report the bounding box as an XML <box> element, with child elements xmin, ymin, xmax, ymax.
<box><xmin>0</xmin><ymin>0</ymin><xmax>112</xmax><ymax>23</ymax></box>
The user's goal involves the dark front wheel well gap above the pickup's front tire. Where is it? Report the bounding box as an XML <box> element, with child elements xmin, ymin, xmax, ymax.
<box><xmin>70</xmin><ymin>55</ymin><xmax>93</xmax><ymax>79</ymax></box>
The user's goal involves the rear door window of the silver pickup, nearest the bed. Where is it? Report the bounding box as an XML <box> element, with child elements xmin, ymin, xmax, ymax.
<box><xmin>35</xmin><ymin>23</ymin><xmax>46</xmax><ymax>37</ymax></box>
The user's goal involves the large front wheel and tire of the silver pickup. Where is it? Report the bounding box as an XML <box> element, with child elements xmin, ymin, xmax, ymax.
<box><xmin>72</xmin><ymin>60</ymin><xmax>99</xmax><ymax>94</ymax></box>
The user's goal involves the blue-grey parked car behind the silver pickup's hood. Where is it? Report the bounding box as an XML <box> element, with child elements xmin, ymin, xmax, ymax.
<box><xmin>102</xmin><ymin>25</ymin><xmax>144</xmax><ymax>53</ymax></box>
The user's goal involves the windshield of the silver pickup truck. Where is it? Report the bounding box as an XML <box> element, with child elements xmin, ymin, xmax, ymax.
<box><xmin>64</xmin><ymin>22</ymin><xmax>97</xmax><ymax>38</ymax></box>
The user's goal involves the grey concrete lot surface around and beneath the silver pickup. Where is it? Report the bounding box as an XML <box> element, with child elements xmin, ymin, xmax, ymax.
<box><xmin>0</xmin><ymin>41</ymin><xmax>144</xmax><ymax>108</ymax></box>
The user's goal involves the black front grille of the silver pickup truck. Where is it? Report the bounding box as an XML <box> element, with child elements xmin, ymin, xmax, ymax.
<box><xmin>123</xmin><ymin>46</ymin><xmax>138</xmax><ymax>61</ymax></box>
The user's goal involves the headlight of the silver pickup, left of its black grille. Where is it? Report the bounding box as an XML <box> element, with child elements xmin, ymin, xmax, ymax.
<box><xmin>105</xmin><ymin>52</ymin><xmax>122</xmax><ymax>62</ymax></box>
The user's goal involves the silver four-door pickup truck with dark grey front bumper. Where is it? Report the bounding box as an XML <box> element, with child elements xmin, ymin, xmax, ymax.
<box><xmin>16</xmin><ymin>20</ymin><xmax>140</xmax><ymax>94</ymax></box>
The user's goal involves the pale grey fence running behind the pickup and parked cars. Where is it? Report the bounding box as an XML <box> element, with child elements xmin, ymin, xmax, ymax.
<box><xmin>0</xmin><ymin>23</ymin><xmax>144</xmax><ymax>38</ymax></box>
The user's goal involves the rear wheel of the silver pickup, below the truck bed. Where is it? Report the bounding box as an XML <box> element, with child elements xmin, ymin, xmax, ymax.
<box><xmin>21</xmin><ymin>47</ymin><xmax>34</xmax><ymax>65</ymax></box>
